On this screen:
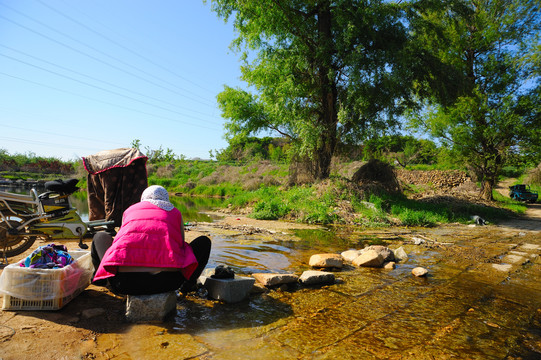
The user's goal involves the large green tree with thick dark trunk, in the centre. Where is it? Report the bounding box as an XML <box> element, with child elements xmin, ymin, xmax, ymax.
<box><xmin>212</xmin><ymin>0</ymin><xmax>411</xmax><ymax>179</ymax></box>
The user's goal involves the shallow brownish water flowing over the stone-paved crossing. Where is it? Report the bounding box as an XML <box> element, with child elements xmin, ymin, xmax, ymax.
<box><xmin>4</xmin><ymin>188</ymin><xmax>541</xmax><ymax>359</ymax></box>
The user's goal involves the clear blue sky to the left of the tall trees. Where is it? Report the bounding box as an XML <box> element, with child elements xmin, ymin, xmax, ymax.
<box><xmin>0</xmin><ymin>0</ymin><xmax>242</xmax><ymax>160</ymax></box>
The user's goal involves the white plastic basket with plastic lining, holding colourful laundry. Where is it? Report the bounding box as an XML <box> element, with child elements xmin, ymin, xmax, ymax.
<box><xmin>0</xmin><ymin>251</ymin><xmax>93</xmax><ymax>310</ymax></box>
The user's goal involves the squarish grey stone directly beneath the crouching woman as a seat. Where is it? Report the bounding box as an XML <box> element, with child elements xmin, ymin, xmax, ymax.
<box><xmin>126</xmin><ymin>291</ymin><xmax>177</xmax><ymax>322</ymax></box>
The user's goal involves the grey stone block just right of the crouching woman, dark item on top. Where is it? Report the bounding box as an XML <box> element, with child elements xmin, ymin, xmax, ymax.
<box><xmin>199</xmin><ymin>276</ymin><xmax>255</xmax><ymax>303</ymax></box>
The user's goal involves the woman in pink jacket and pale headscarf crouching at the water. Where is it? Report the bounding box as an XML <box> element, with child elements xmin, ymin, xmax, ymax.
<box><xmin>91</xmin><ymin>185</ymin><xmax>211</xmax><ymax>295</ymax></box>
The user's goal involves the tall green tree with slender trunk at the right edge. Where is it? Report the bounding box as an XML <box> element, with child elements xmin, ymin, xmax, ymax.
<box><xmin>412</xmin><ymin>0</ymin><xmax>541</xmax><ymax>200</ymax></box>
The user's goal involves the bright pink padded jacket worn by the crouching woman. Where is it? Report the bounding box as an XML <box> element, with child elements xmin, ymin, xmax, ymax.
<box><xmin>94</xmin><ymin>201</ymin><xmax>197</xmax><ymax>281</ymax></box>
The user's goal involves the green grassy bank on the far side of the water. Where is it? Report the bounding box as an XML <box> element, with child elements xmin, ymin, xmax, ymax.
<box><xmin>143</xmin><ymin>160</ymin><xmax>524</xmax><ymax>227</ymax></box>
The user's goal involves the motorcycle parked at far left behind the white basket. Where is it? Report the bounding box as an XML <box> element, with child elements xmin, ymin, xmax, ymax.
<box><xmin>0</xmin><ymin>179</ymin><xmax>114</xmax><ymax>264</ymax></box>
